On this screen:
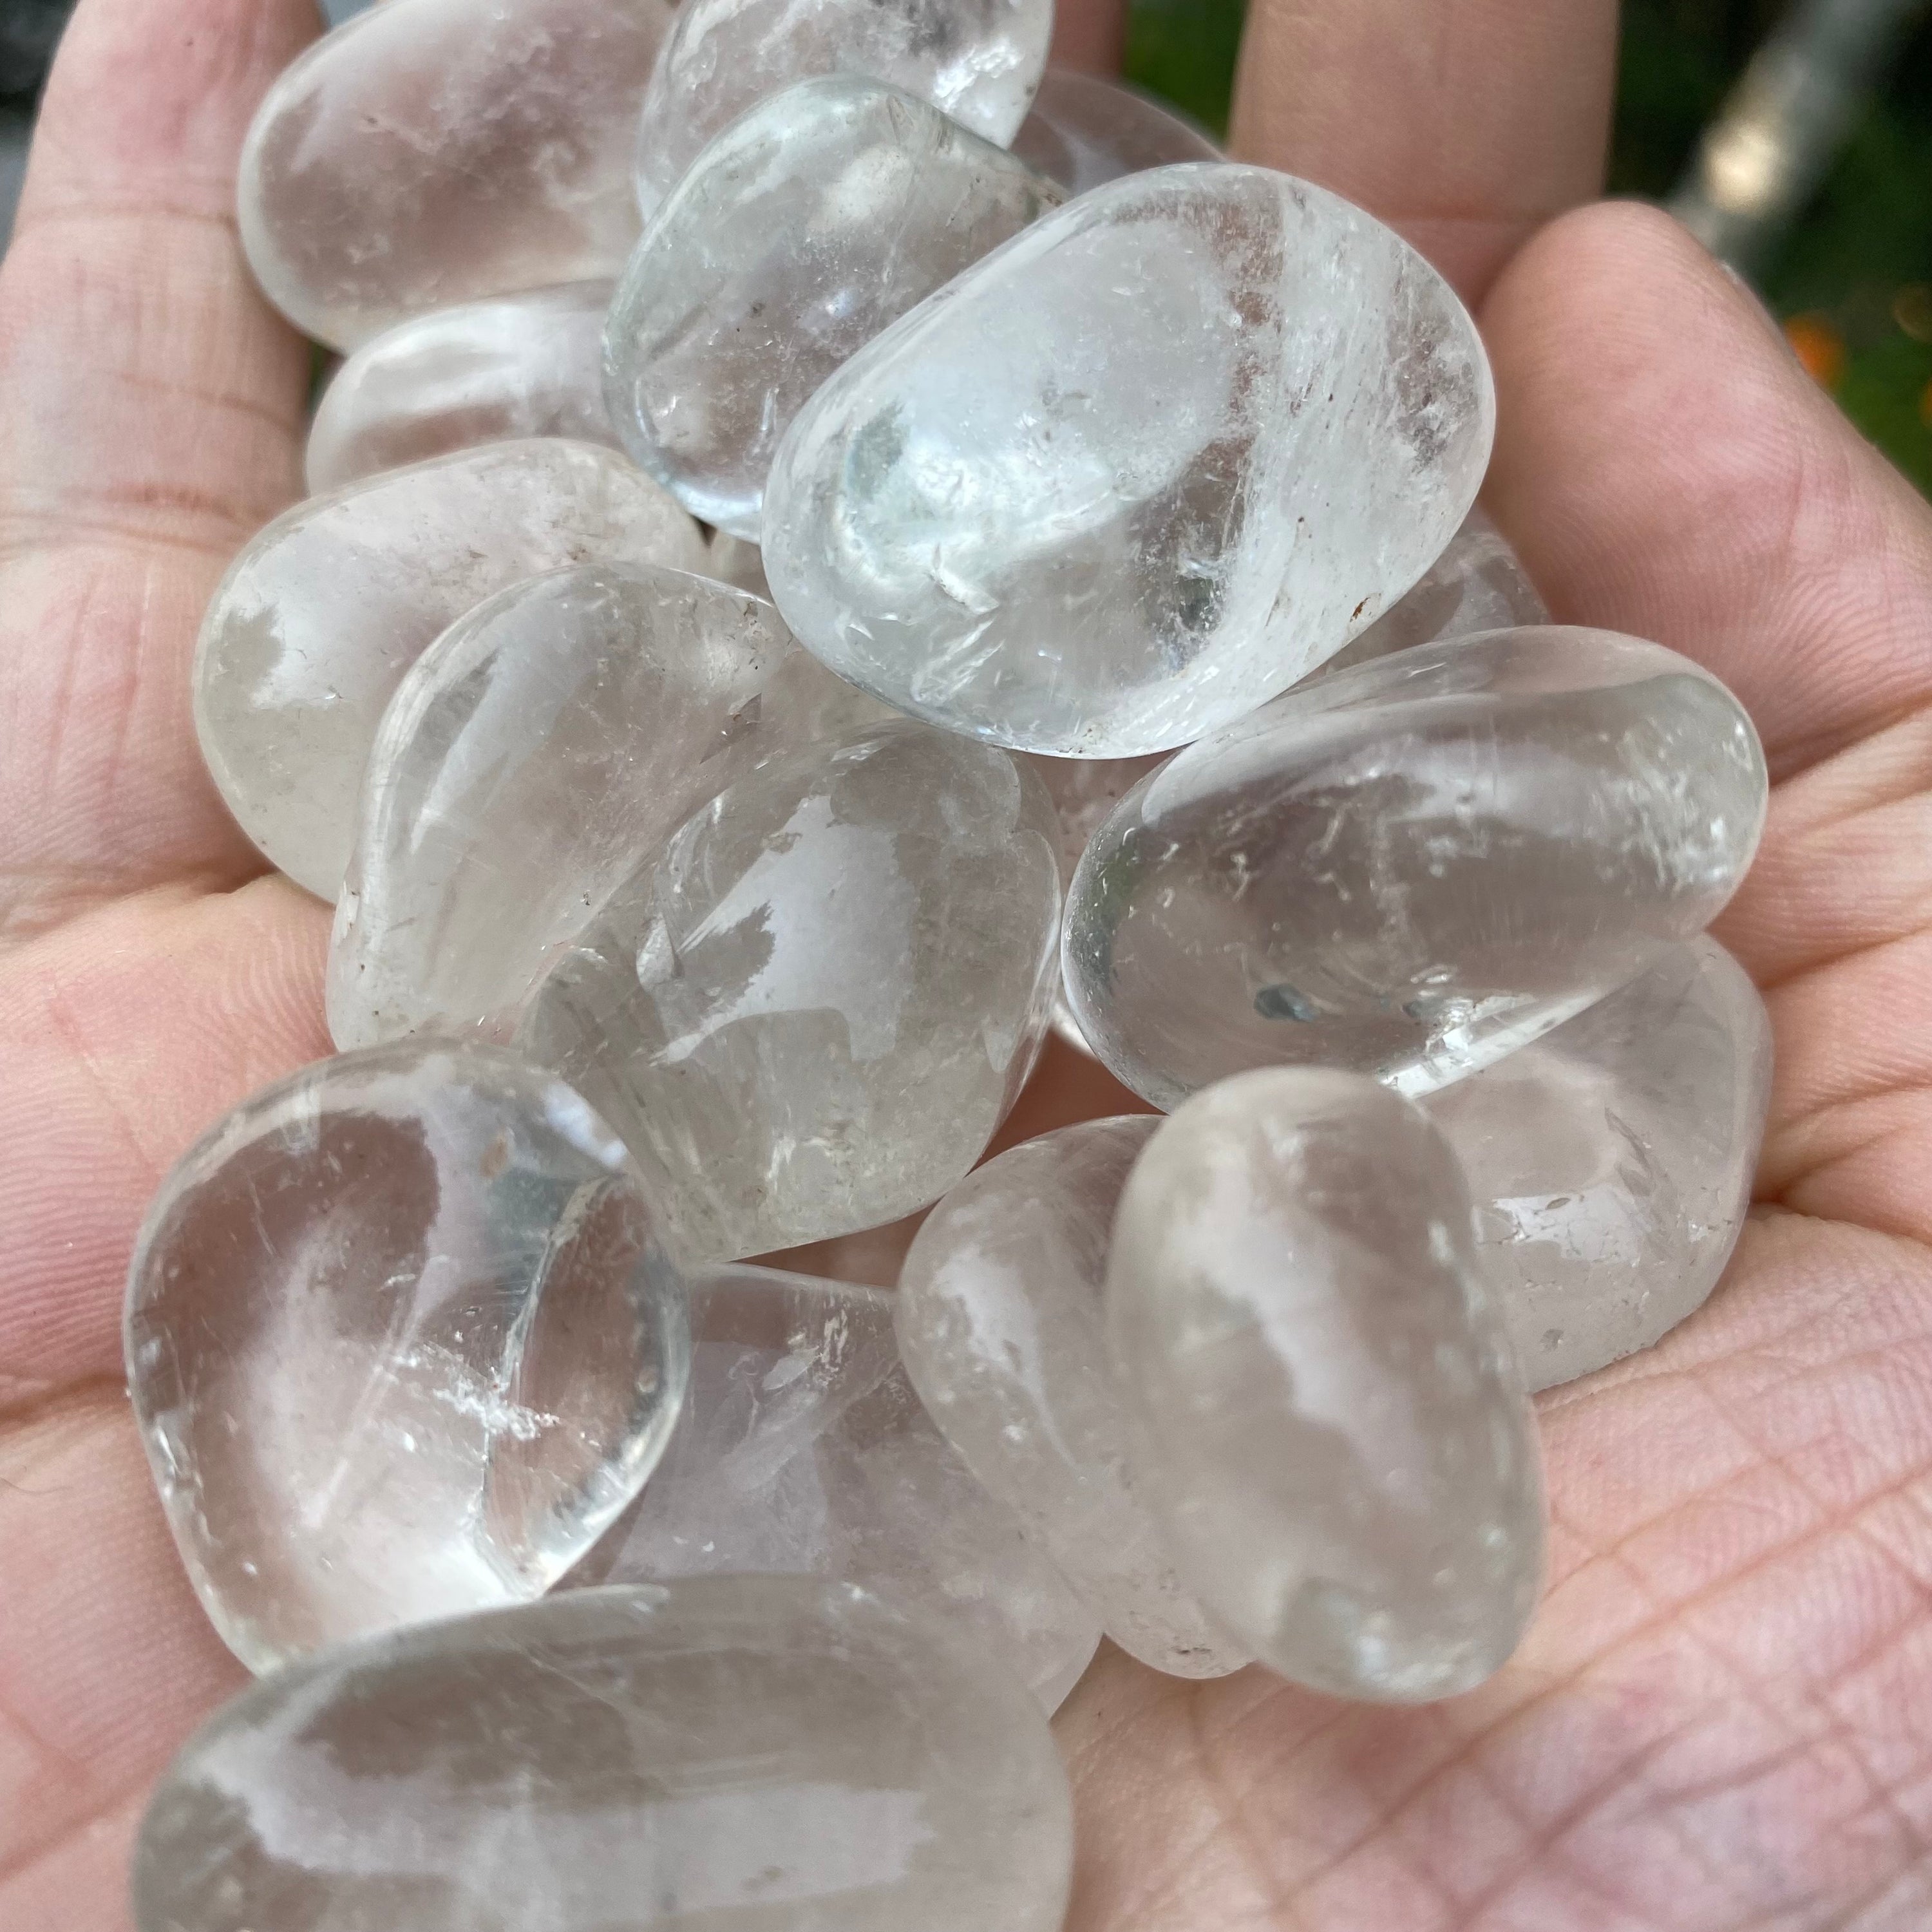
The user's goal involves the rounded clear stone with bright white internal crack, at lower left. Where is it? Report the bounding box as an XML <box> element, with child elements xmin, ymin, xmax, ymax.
<box><xmin>126</xmin><ymin>1041</ymin><xmax>690</xmax><ymax>1671</ymax></box>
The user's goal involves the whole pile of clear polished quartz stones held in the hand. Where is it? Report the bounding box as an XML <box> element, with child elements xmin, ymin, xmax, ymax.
<box><xmin>128</xmin><ymin>0</ymin><xmax>1770</xmax><ymax>1932</ymax></box>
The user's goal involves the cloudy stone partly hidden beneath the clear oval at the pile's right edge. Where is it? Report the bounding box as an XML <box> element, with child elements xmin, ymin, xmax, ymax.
<box><xmin>1424</xmin><ymin>939</ymin><xmax>1772</xmax><ymax>1391</ymax></box>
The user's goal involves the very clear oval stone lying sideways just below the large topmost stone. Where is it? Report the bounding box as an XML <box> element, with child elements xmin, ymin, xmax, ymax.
<box><xmin>1065</xmin><ymin>626</ymin><xmax>1766</xmax><ymax>1107</ymax></box>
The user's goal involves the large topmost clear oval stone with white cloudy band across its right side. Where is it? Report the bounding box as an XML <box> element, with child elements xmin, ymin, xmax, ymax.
<box><xmin>763</xmin><ymin>162</ymin><xmax>1495</xmax><ymax>757</ymax></box>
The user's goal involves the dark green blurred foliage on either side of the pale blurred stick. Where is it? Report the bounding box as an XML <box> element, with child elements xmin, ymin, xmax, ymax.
<box><xmin>1126</xmin><ymin>0</ymin><xmax>1932</xmax><ymax>493</ymax></box>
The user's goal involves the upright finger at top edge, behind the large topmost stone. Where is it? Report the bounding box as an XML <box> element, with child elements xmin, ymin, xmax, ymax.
<box><xmin>1233</xmin><ymin>0</ymin><xmax>1617</xmax><ymax>301</ymax></box>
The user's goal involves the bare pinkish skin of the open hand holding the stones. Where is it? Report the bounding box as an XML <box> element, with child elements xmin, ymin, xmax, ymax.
<box><xmin>0</xmin><ymin>0</ymin><xmax>1932</xmax><ymax>1932</ymax></box>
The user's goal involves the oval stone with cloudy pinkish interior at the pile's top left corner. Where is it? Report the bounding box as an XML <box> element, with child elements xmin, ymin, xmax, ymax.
<box><xmin>238</xmin><ymin>0</ymin><xmax>672</xmax><ymax>350</ymax></box>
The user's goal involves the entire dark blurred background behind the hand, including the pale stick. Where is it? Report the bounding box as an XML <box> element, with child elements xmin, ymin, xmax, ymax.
<box><xmin>0</xmin><ymin>0</ymin><xmax>1932</xmax><ymax>493</ymax></box>
